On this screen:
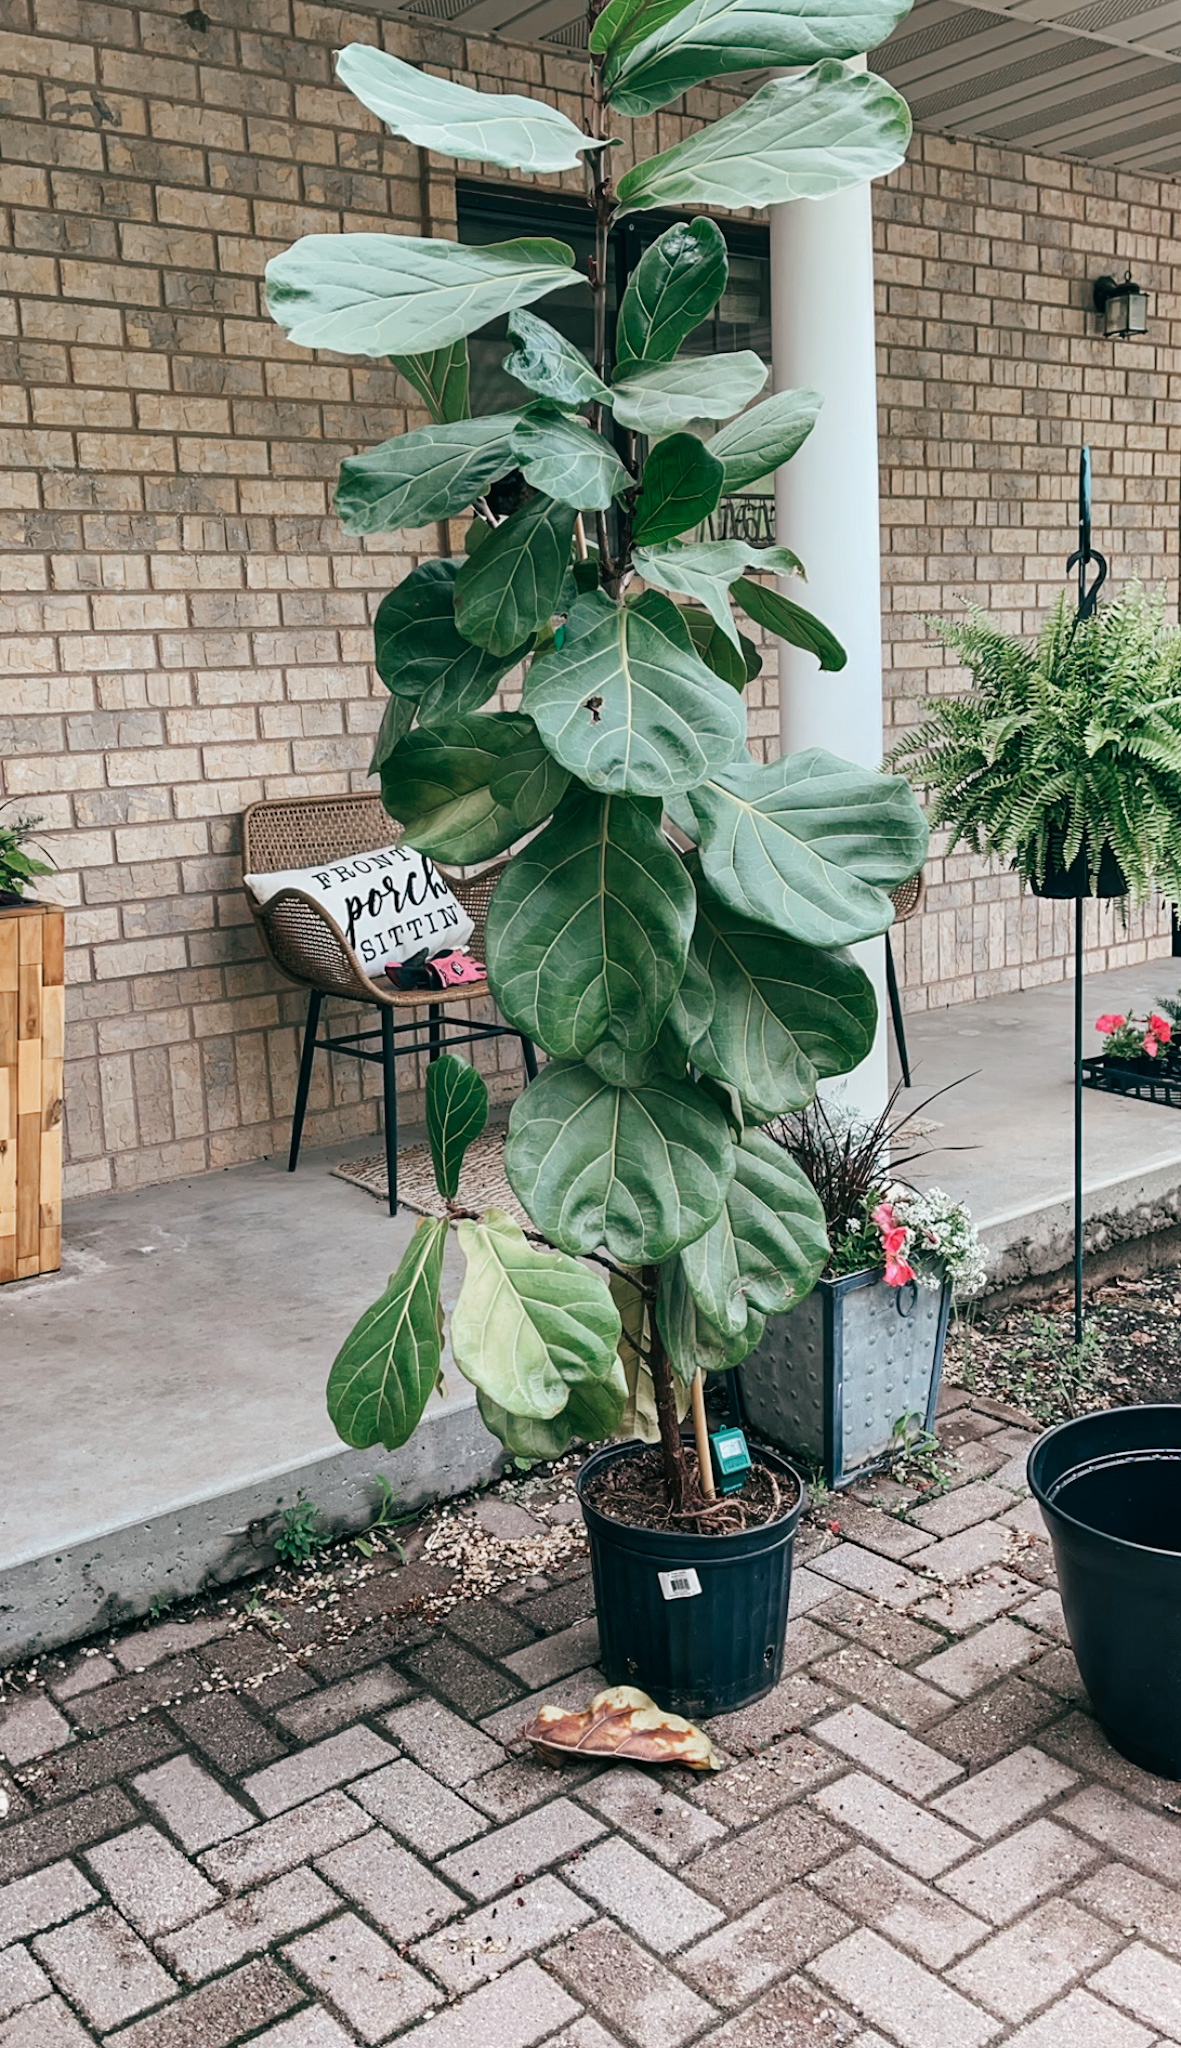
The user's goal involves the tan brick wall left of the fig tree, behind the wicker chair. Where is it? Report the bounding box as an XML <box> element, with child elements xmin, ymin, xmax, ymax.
<box><xmin>0</xmin><ymin>0</ymin><xmax>778</xmax><ymax>1194</ymax></box>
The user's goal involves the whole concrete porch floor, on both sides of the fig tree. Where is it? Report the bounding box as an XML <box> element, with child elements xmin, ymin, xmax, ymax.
<box><xmin>0</xmin><ymin>961</ymin><xmax>1181</xmax><ymax>1661</ymax></box>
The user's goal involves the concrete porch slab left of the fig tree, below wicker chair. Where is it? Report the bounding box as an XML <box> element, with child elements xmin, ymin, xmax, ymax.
<box><xmin>0</xmin><ymin>1130</ymin><xmax>499</xmax><ymax>1663</ymax></box>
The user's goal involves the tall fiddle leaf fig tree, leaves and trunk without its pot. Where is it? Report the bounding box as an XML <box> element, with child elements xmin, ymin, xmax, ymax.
<box><xmin>278</xmin><ymin>0</ymin><xmax>925</xmax><ymax>1522</ymax></box>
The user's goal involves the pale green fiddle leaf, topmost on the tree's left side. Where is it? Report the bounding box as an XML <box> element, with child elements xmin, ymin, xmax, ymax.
<box><xmin>336</xmin><ymin>43</ymin><xmax>601</xmax><ymax>174</ymax></box>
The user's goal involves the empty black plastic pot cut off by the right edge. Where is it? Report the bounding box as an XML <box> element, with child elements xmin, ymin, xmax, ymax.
<box><xmin>1030</xmin><ymin>1403</ymin><xmax>1181</xmax><ymax>1778</ymax></box>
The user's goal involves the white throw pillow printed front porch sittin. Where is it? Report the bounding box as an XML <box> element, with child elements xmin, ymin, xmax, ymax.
<box><xmin>246</xmin><ymin>846</ymin><xmax>475</xmax><ymax>975</ymax></box>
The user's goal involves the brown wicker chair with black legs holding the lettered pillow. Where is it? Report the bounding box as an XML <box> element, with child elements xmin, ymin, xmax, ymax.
<box><xmin>242</xmin><ymin>795</ymin><xmax>536</xmax><ymax>1217</ymax></box>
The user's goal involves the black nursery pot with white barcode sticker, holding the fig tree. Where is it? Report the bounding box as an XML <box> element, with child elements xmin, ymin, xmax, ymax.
<box><xmin>577</xmin><ymin>1444</ymin><xmax>804</xmax><ymax>1720</ymax></box>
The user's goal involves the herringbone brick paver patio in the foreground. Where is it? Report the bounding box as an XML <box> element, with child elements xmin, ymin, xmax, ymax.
<box><xmin>0</xmin><ymin>1395</ymin><xmax>1181</xmax><ymax>2048</ymax></box>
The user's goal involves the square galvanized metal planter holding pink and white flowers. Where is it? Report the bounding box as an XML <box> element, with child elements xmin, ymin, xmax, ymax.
<box><xmin>737</xmin><ymin>1270</ymin><xmax>952</xmax><ymax>1487</ymax></box>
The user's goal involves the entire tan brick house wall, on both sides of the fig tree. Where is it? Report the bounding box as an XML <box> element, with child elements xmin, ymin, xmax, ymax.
<box><xmin>0</xmin><ymin>0</ymin><xmax>1181</xmax><ymax>1194</ymax></box>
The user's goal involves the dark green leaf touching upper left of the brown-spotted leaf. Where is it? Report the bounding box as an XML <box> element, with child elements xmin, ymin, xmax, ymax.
<box><xmin>454</xmin><ymin>498</ymin><xmax>577</xmax><ymax>653</ymax></box>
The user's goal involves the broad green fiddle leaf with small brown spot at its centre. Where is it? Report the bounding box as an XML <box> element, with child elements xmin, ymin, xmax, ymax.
<box><xmin>522</xmin><ymin>590</ymin><xmax>747</xmax><ymax>799</ymax></box>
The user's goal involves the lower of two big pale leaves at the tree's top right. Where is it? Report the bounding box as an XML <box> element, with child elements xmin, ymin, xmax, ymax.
<box><xmin>618</xmin><ymin>59</ymin><xmax>911</xmax><ymax>216</ymax></box>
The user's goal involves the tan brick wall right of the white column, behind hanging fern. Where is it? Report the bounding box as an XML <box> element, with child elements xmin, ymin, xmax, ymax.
<box><xmin>874</xmin><ymin>135</ymin><xmax>1181</xmax><ymax>1010</ymax></box>
